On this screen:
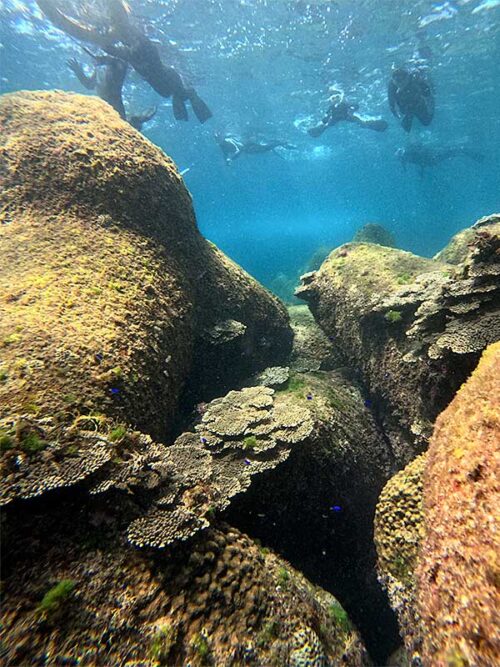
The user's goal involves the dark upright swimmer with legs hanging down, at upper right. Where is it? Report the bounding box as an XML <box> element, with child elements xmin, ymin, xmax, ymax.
<box><xmin>387</xmin><ymin>67</ymin><xmax>434</xmax><ymax>132</ymax></box>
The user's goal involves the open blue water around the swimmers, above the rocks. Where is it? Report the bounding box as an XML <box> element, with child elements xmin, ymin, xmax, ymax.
<box><xmin>0</xmin><ymin>0</ymin><xmax>500</xmax><ymax>298</ymax></box>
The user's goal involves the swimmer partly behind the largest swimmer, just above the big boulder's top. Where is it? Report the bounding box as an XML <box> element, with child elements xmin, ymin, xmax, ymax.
<box><xmin>68</xmin><ymin>49</ymin><xmax>156</xmax><ymax>131</ymax></box>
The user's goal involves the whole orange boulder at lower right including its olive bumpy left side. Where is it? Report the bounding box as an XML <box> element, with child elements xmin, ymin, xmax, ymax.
<box><xmin>375</xmin><ymin>343</ymin><xmax>500</xmax><ymax>667</ymax></box>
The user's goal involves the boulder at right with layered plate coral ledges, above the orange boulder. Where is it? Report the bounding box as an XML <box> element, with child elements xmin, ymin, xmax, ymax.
<box><xmin>297</xmin><ymin>228</ymin><xmax>500</xmax><ymax>465</ymax></box>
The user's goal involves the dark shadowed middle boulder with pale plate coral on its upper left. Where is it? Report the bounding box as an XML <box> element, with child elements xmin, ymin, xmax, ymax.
<box><xmin>223</xmin><ymin>372</ymin><xmax>395</xmax><ymax>659</ymax></box>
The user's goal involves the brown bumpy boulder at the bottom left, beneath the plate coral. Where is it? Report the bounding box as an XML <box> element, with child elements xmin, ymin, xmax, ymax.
<box><xmin>2</xmin><ymin>502</ymin><xmax>370</xmax><ymax>667</ymax></box>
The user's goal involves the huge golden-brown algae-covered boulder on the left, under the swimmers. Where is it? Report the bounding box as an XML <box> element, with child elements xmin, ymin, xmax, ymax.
<box><xmin>0</xmin><ymin>92</ymin><xmax>292</xmax><ymax>500</ymax></box>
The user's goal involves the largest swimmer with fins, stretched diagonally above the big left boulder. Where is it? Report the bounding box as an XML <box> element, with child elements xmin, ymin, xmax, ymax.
<box><xmin>37</xmin><ymin>0</ymin><xmax>212</xmax><ymax>123</ymax></box>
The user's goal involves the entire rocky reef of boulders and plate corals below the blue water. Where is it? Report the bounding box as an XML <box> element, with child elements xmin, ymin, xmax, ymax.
<box><xmin>0</xmin><ymin>92</ymin><xmax>500</xmax><ymax>667</ymax></box>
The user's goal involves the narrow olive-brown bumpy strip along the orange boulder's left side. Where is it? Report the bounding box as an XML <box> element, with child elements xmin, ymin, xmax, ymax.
<box><xmin>374</xmin><ymin>454</ymin><xmax>426</xmax><ymax>665</ymax></box>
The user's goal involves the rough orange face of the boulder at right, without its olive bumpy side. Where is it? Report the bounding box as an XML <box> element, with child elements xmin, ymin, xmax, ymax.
<box><xmin>417</xmin><ymin>343</ymin><xmax>500</xmax><ymax>667</ymax></box>
